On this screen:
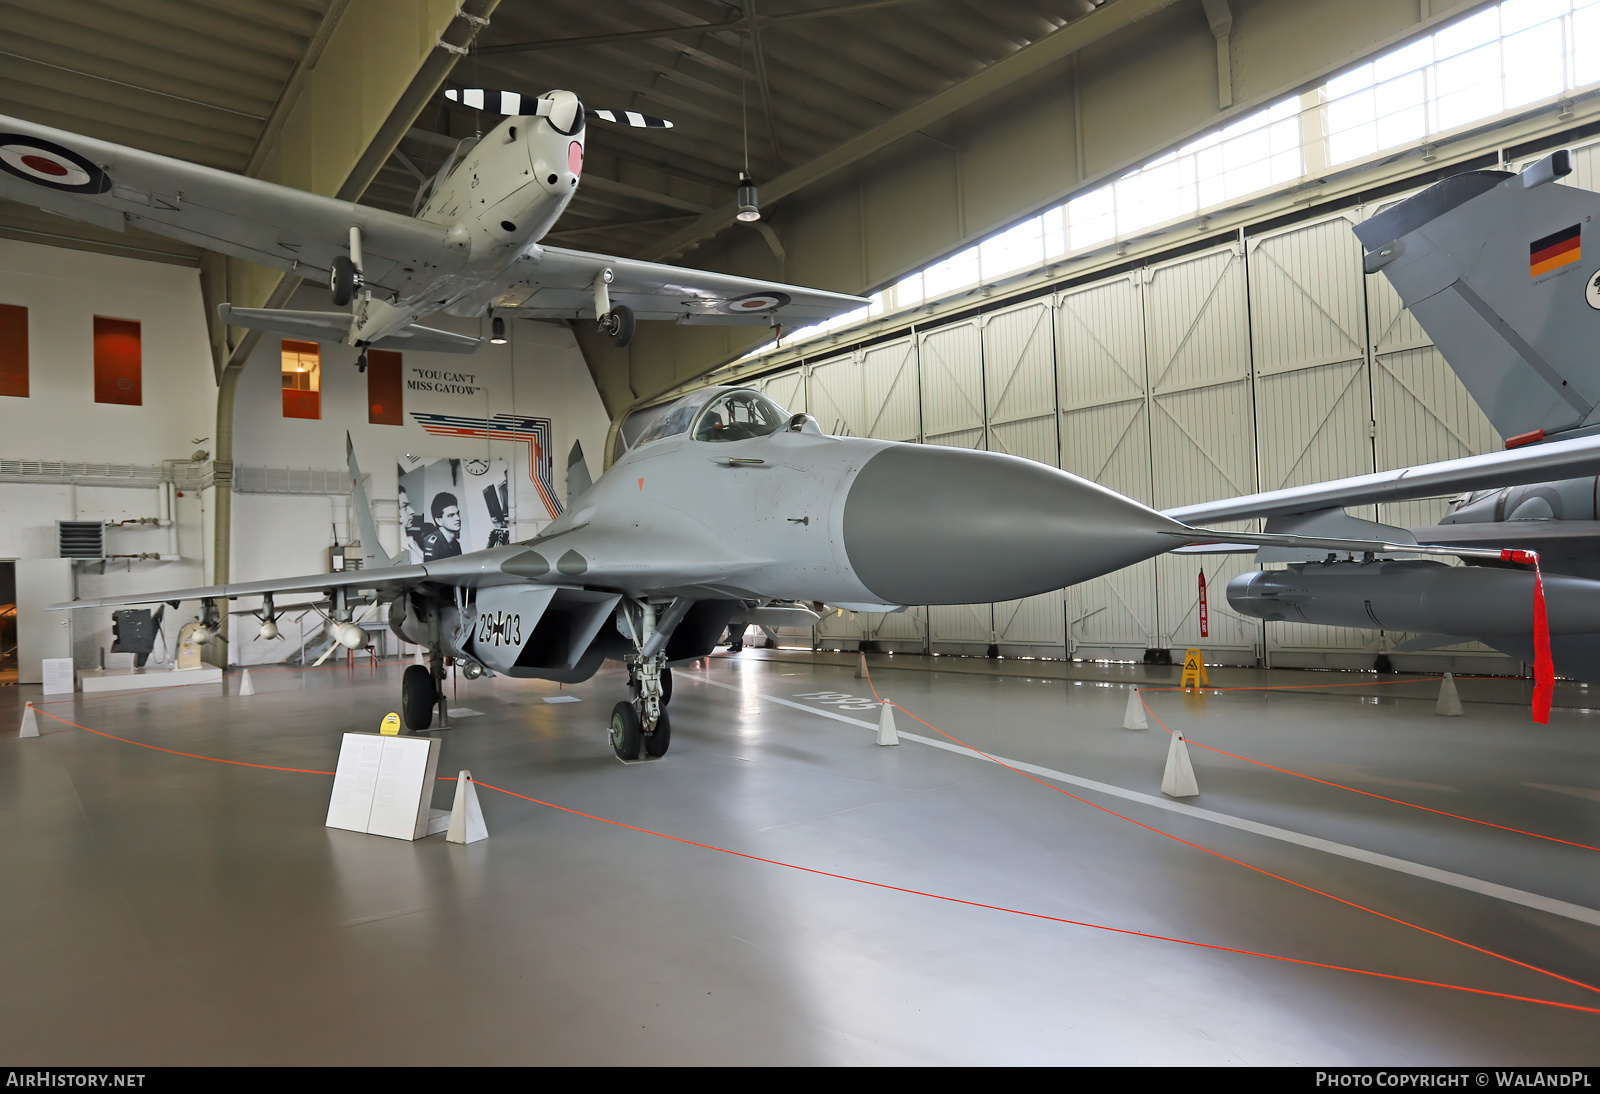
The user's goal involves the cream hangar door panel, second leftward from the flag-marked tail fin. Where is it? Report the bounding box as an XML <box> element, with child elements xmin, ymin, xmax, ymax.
<box><xmin>1248</xmin><ymin>216</ymin><xmax>1373</xmax><ymax>649</ymax></box>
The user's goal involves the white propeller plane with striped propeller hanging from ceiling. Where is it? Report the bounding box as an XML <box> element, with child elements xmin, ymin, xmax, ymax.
<box><xmin>0</xmin><ymin>91</ymin><xmax>867</xmax><ymax>368</ymax></box>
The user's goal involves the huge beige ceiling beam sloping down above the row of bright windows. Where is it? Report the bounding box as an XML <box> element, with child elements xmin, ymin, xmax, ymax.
<box><xmin>588</xmin><ymin>0</ymin><xmax>1488</xmax><ymax>414</ymax></box>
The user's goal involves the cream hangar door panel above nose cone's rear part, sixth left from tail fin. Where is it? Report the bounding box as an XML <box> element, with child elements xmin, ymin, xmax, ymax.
<box><xmin>918</xmin><ymin>320</ymin><xmax>994</xmax><ymax>654</ymax></box>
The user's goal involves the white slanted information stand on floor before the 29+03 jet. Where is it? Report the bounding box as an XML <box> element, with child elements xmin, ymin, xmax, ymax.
<box><xmin>328</xmin><ymin>733</ymin><xmax>450</xmax><ymax>840</ymax></box>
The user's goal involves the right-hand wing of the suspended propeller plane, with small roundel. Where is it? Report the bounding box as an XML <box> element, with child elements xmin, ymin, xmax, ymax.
<box><xmin>494</xmin><ymin>246</ymin><xmax>869</xmax><ymax>328</ymax></box>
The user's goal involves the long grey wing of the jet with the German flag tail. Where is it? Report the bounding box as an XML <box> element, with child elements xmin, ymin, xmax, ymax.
<box><xmin>1165</xmin><ymin>437</ymin><xmax>1600</xmax><ymax>524</ymax></box>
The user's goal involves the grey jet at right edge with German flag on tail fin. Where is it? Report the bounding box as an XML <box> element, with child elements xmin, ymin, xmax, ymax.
<box><xmin>1168</xmin><ymin>150</ymin><xmax>1600</xmax><ymax>683</ymax></box>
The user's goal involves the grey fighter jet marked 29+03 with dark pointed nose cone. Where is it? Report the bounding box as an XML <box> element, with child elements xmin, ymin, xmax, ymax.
<box><xmin>53</xmin><ymin>387</ymin><xmax>1600</xmax><ymax>760</ymax></box>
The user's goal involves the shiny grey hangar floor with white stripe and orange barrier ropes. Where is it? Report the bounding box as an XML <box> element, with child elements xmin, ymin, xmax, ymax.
<box><xmin>0</xmin><ymin>649</ymin><xmax>1600</xmax><ymax>1065</ymax></box>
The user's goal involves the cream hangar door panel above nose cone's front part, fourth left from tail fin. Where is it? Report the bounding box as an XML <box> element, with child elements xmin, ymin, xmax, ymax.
<box><xmin>1056</xmin><ymin>277</ymin><xmax>1155</xmax><ymax>657</ymax></box>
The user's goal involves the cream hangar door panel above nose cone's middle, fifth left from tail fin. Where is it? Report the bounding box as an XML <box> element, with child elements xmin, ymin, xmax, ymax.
<box><xmin>982</xmin><ymin>301</ymin><xmax>1067</xmax><ymax>657</ymax></box>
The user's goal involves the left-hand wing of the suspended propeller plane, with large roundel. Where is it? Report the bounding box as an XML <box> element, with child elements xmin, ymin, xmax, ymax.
<box><xmin>0</xmin><ymin>117</ymin><xmax>464</xmax><ymax>291</ymax></box>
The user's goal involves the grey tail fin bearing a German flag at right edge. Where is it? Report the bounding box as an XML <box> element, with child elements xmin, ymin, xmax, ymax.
<box><xmin>1355</xmin><ymin>150</ymin><xmax>1600</xmax><ymax>448</ymax></box>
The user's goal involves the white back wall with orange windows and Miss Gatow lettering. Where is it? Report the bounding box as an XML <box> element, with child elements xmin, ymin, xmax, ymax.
<box><xmin>0</xmin><ymin>240</ymin><xmax>608</xmax><ymax>669</ymax></box>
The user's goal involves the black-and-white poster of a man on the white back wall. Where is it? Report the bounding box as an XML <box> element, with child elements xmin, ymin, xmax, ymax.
<box><xmin>397</xmin><ymin>456</ymin><xmax>512</xmax><ymax>563</ymax></box>
